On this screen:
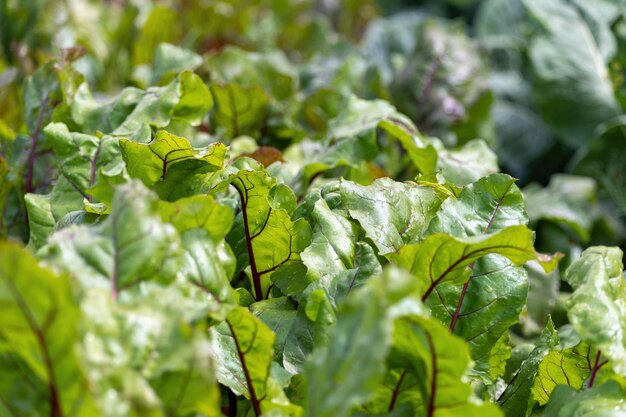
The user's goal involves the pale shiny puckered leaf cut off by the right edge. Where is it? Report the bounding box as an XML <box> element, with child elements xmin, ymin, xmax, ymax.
<box><xmin>565</xmin><ymin>246</ymin><xmax>626</xmax><ymax>375</ymax></box>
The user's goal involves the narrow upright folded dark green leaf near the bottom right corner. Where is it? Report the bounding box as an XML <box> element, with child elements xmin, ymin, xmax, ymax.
<box><xmin>497</xmin><ymin>320</ymin><xmax>559</xmax><ymax>417</ymax></box>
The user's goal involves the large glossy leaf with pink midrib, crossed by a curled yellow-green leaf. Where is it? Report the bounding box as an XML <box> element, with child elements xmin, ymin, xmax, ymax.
<box><xmin>428</xmin><ymin>174</ymin><xmax>528</xmax><ymax>381</ymax></box>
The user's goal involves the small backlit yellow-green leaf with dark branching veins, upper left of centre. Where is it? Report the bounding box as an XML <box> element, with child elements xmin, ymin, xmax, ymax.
<box><xmin>120</xmin><ymin>130</ymin><xmax>226</xmax><ymax>187</ymax></box>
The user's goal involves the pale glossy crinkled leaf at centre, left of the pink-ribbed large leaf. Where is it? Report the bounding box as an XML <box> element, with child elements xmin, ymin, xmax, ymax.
<box><xmin>339</xmin><ymin>178</ymin><xmax>441</xmax><ymax>255</ymax></box>
